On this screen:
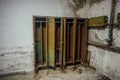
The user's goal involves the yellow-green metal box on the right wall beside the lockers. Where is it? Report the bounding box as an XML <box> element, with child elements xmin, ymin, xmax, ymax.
<box><xmin>88</xmin><ymin>16</ymin><xmax>108</xmax><ymax>27</ymax></box>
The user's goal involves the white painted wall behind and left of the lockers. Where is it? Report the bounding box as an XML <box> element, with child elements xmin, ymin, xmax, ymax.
<box><xmin>0</xmin><ymin>0</ymin><xmax>73</xmax><ymax>74</ymax></box>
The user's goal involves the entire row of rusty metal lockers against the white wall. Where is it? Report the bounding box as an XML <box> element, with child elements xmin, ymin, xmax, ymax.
<box><xmin>34</xmin><ymin>17</ymin><xmax>88</xmax><ymax>72</ymax></box>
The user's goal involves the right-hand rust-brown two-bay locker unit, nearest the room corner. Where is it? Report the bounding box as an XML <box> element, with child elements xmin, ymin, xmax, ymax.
<box><xmin>63</xmin><ymin>18</ymin><xmax>87</xmax><ymax>67</ymax></box>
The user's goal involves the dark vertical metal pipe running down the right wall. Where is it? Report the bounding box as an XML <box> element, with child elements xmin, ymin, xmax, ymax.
<box><xmin>107</xmin><ymin>0</ymin><xmax>116</xmax><ymax>45</ymax></box>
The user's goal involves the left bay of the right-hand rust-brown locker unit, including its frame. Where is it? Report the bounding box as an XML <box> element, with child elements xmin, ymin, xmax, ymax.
<box><xmin>63</xmin><ymin>18</ymin><xmax>76</xmax><ymax>67</ymax></box>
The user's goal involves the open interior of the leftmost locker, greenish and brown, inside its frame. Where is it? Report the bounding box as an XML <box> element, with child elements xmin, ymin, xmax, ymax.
<box><xmin>35</xmin><ymin>18</ymin><xmax>46</xmax><ymax>65</ymax></box>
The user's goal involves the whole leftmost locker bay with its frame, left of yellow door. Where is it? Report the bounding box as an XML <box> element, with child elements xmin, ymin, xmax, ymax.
<box><xmin>34</xmin><ymin>16</ymin><xmax>48</xmax><ymax>70</ymax></box>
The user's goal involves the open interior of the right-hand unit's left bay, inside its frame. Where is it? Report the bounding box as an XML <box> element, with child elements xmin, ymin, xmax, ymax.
<box><xmin>66</xmin><ymin>18</ymin><xmax>75</xmax><ymax>63</ymax></box>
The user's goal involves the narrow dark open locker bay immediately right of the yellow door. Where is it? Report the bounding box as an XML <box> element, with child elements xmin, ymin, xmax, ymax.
<box><xmin>55</xmin><ymin>17</ymin><xmax>63</xmax><ymax>68</ymax></box>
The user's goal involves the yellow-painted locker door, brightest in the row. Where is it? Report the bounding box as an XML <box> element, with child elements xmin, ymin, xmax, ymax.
<box><xmin>48</xmin><ymin>17</ymin><xmax>55</xmax><ymax>68</ymax></box>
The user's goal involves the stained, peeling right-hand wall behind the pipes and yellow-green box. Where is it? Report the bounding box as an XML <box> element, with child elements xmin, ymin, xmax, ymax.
<box><xmin>68</xmin><ymin>0</ymin><xmax>120</xmax><ymax>80</ymax></box>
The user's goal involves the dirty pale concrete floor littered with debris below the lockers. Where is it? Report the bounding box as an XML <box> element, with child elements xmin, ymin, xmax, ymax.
<box><xmin>0</xmin><ymin>67</ymin><xmax>112</xmax><ymax>80</ymax></box>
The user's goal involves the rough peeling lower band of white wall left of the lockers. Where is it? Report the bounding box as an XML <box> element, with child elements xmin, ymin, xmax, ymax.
<box><xmin>0</xmin><ymin>47</ymin><xmax>34</xmax><ymax>74</ymax></box>
